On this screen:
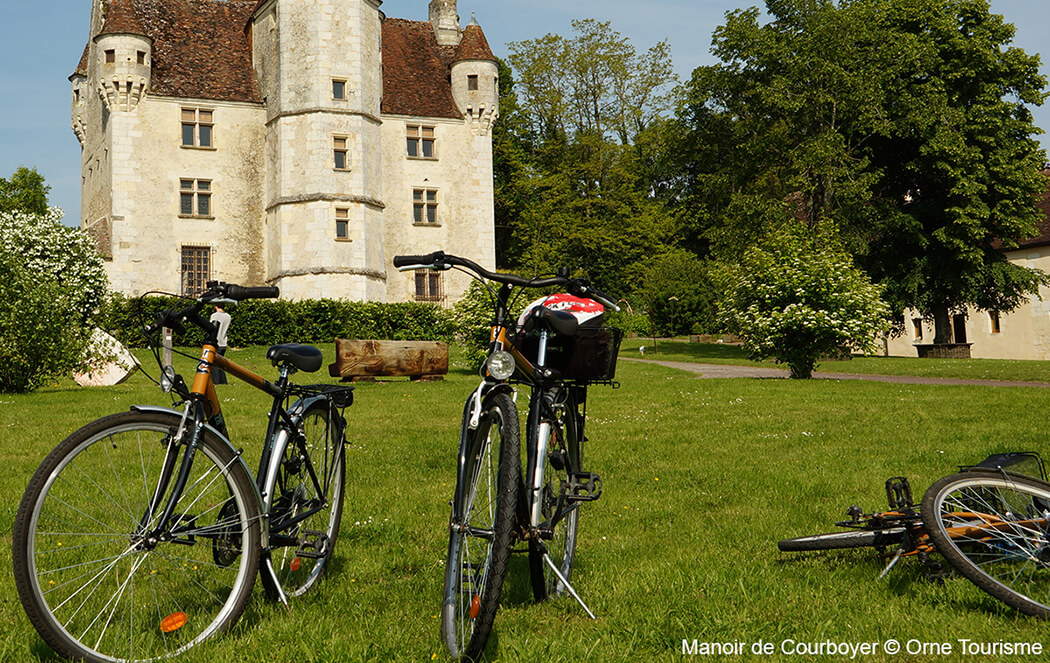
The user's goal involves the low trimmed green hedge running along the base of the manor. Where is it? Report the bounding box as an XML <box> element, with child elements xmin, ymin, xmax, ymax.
<box><xmin>101</xmin><ymin>294</ymin><xmax>455</xmax><ymax>348</ymax></box>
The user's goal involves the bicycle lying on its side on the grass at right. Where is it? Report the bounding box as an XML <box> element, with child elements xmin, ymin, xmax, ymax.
<box><xmin>778</xmin><ymin>453</ymin><xmax>1050</xmax><ymax>619</ymax></box>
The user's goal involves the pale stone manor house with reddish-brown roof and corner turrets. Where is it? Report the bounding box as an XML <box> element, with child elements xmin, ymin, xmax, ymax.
<box><xmin>69</xmin><ymin>0</ymin><xmax>498</xmax><ymax>302</ymax></box>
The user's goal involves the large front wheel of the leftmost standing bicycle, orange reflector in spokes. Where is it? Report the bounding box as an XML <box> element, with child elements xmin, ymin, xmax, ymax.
<box><xmin>13</xmin><ymin>412</ymin><xmax>260</xmax><ymax>661</ymax></box>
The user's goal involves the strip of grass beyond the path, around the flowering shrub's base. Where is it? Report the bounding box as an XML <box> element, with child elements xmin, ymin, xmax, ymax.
<box><xmin>621</xmin><ymin>338</ymin><xmax>1050</xmax><ymax>382</ymax></box>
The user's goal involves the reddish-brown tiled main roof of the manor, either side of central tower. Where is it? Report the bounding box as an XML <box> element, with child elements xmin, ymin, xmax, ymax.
<box><xmin>75</xmin><ymin>0</ymin><xmax>495</xmax><ymax>118</ymax></box>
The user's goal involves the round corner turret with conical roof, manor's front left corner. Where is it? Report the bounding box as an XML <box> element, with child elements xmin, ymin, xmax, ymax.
<box><xmin>95</xmin><ymin>0</ymin><xmax>153</xmax><ymax>112</ymax></box>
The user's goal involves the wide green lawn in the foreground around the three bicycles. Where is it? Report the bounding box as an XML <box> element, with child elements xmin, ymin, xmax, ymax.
<box><xmin>0</xmin><ymin>344</ymin><xmax>1050</xmax><ymax>662</ymax></box>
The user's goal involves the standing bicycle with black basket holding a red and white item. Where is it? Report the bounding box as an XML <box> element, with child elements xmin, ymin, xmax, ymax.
<box><xmin>394</xmin><ymin>251</ymin><xmax>621</xmax><ymax>660</ymax></box>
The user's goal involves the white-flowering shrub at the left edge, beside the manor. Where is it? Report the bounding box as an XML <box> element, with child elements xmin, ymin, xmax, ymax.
<box><xmin>0</xmin><ymin>208</ymin><xmax>107</xmax><ymax>393</ymax></box>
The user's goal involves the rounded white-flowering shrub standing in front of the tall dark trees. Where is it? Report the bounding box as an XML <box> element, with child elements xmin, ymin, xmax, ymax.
<box><xmin>719</xmin><ymin>229</ymin><xmax>888</xmax><ymax>378</ymax></box>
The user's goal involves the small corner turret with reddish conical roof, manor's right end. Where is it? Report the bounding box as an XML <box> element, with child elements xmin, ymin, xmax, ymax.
<box><xmin>451</xmin><ymin>15</ymin><xmax>500</xmax><ymax>133</ymax></box>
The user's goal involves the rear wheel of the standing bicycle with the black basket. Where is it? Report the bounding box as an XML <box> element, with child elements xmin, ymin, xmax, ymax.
<box><xmin>527</xmin><ymin>388</ymin><xmax>581</xmax><ymax>601</ymax></box>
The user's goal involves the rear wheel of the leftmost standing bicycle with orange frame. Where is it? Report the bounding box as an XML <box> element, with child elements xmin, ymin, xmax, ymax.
<box><xmin>263</xmin><ymin>400</ymin><xmax>347</xmax><ymax>598</ymax></box>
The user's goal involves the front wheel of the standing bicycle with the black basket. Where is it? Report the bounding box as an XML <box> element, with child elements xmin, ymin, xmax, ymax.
<box><xmin>441</xmin><ymin>393</ymin><xmax>521</xmax><ymax>661</ymax></box>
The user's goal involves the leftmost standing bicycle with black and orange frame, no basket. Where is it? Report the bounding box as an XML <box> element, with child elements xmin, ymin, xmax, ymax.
<box><xmin>13</xmin><ymin>283</ymin><xmax>353</xmax><ymax>661</ymax></box>
